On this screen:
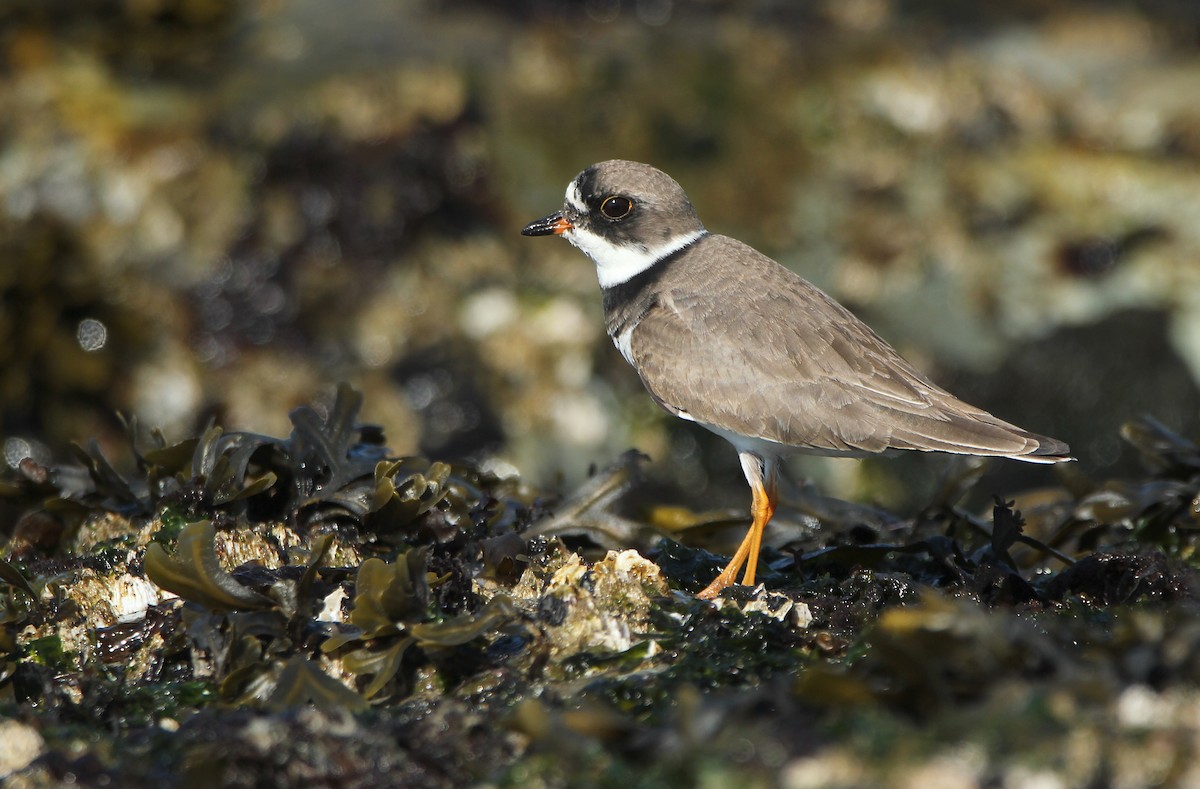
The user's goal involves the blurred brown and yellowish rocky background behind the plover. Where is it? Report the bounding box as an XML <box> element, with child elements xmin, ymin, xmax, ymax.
<box><xmin>0</xmin><ymin>0</ymin><xmax>1200</xmax><ymax>508</ymax></box>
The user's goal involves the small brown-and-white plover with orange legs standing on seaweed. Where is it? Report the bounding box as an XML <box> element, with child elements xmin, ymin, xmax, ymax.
<box><xmin>521</xmin><ymin>159</ymin><xmax>1072</xmax><ymax>600</ymax></box>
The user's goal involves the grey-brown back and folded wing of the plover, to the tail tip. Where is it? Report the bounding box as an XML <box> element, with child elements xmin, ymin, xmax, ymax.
<box><xmin>631</xmin><ymin>236</ymin><xmax>1068</xmax><ymax>462</ymax></box>
